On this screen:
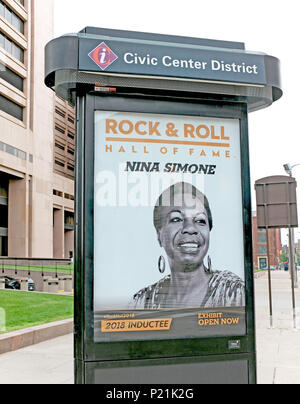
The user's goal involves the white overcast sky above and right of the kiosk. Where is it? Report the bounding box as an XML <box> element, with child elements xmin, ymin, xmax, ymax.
<box><xmin>54</xmin><ymin>0</ymin><xmax>300</xmax><ymax>242</ymax></box>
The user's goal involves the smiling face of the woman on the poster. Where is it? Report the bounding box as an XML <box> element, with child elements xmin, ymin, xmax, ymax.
<box><xmin>158</xmin><ymin>194</ymin><xmax>210</xmax><ymax>270</ymax></box>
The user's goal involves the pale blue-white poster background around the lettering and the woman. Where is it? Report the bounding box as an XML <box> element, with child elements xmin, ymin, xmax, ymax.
<box><xmin>94</xmin><ymin>111</ymin><xmax>245</xmax><ymax>311</ymax></box>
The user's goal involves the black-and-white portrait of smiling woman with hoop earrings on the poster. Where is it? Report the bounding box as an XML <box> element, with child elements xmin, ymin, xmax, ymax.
<box><xmin>132</xmin><ymin>182</ymin><xmax>245</xmax><ymax>309</ymax></box>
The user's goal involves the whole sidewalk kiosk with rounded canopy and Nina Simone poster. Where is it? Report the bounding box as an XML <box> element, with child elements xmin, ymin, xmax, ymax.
<box><xmin>45</xmin><ymin>28</ymin><xmax>282</xmax><ymax>386</ymax></box>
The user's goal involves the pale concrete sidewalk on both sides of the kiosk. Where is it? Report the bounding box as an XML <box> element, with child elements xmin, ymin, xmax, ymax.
<box><xmin>0</xmin><ymin>271</ymin><xmax>300</xmax><ymax>384</ymax></box>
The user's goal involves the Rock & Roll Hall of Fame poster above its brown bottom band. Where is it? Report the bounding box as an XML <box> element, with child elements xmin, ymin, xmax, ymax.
<box><xmin>93</xmin><ymin>111</ymin><xmax>245</xmax><ymax>328</ymax></box>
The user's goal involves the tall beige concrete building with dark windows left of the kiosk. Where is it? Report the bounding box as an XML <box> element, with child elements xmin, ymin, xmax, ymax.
<box><xmin>0</xmin><ymin>0</ymin><xmax>75</xmax><ymax>258</ymax></box>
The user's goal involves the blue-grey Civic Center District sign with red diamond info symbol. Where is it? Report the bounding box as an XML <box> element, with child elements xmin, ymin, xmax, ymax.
<box><xmin>80</xmin><ymin>40</ymin><xmax>266</xmax><ymax>84</ymax></box>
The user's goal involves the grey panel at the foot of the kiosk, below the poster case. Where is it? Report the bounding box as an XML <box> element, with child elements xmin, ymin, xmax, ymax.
<box><xmin>77</xmin><ymin>354</ymin><xmax>255</xmax><ymax>385</ymax></box>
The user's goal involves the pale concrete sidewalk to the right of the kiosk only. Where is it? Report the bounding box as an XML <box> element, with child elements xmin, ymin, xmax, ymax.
<box><xmin>255</xmin><ymin>271</ymin><xmax>300</xmax><ymax>384</ymax></box>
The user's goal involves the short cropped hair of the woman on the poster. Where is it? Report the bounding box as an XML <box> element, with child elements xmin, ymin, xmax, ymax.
<box><xmin>153</xmin><ymin>182</ymin><xmax>213</xmax><ymax>231</ymax></box>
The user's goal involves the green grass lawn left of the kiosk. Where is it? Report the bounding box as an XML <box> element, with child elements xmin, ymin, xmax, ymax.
<box><xmin>0</xmin><ymin>290</ymin><xmax>74</xmax><ymax>334</ymax></box>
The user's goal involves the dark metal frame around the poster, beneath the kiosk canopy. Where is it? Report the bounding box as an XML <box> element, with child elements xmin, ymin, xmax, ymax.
<box><xmin>75</xmin><ymin>95</ymin><xmax>256</xmax><ymax>384</ymax></box>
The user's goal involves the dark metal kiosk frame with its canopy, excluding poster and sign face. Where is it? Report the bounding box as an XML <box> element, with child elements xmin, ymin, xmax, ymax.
<box><xmin>46</xmin><ymin>29</ymin><xmax>282</xmax><ymax>384</ymax></box>
